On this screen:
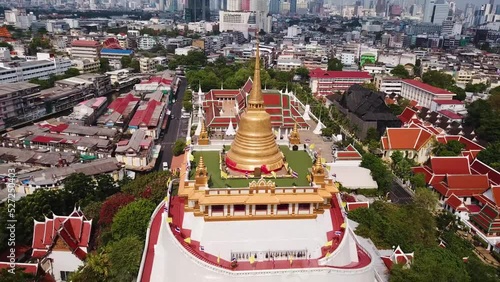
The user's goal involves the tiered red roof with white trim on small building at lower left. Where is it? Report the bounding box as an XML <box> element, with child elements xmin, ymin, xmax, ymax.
<box><xmin>32</xmin><ymin>209</ymin><xmax>92</xmax><ymax>260</ymax></box>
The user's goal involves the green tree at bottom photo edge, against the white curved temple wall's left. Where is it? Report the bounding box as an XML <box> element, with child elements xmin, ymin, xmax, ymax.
<box><xmin>109</xmin><ymin>236</ymin><xmax>144</xmax><ymax>281</ymax></box>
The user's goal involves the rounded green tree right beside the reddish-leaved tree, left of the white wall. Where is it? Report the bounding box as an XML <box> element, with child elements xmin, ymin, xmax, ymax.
<box><xmin>111</xmin><ymin>199</ymin><xmax>156</xmax><ymax>240</ymax></box>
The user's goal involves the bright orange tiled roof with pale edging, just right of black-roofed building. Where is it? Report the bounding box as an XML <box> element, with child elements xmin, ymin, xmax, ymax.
<box><xmin>386</xmin><ymin>128</ymin><xmax>432</xmax><ymax>151</ymax></box>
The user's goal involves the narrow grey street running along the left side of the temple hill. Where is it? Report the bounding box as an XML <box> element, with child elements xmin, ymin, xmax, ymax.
<box><xmin>156</xmin><ymin>78</ymin><xmax>189</xmax><ymax>170</ymax></box>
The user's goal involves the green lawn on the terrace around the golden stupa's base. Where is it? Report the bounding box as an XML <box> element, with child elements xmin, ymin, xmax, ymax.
<box><xmin>189</xmin><ymin>146</ymin><xmax>312</xmax><ymax>188</ymax></box>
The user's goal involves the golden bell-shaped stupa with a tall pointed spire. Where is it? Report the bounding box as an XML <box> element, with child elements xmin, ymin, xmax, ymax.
<box><xmin>226</xmin><ymin>43</ymin><xmax>284</xmax><ymax>173</ymax></box>
